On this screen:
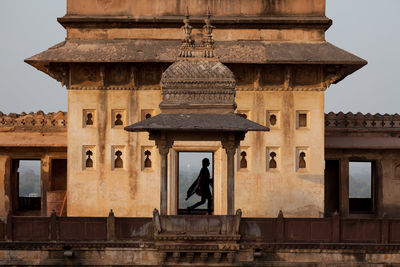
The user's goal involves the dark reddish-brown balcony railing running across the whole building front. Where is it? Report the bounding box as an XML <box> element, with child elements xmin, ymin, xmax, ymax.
<box><xmin>0</xmin><ymin>212</ymin><xmax>400</xmax><ymax>244</ymax></box>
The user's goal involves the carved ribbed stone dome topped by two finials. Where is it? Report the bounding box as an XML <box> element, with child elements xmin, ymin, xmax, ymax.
<box><xmin>160</xmin><ymin>12</ymin><xmax>236</xmax><ymax>113</ymax></box>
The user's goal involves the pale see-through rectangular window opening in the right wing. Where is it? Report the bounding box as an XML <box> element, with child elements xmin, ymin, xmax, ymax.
<box><xmin>349</xmin><ymin>161</ymin><xmax>374</xmax><ymax>213</ymax></box>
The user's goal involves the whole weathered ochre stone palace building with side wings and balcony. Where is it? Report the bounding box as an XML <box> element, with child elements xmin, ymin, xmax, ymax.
<box><xmin>0</xmin><ymin>0</ymin><xmax>400</xmax><ymax>266</ymax></box>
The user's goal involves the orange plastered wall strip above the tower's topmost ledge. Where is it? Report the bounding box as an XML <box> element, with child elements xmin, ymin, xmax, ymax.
<box><xmin>67</xmin><ymin>0</ymin><xmax>325</xmax><ymax>17</ymax></box>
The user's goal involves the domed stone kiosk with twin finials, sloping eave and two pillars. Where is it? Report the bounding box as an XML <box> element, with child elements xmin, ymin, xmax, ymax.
<box><xmin>125</xmin><ymin>14</ymin><xmax>269</xmax><ymax>215</ymax></box>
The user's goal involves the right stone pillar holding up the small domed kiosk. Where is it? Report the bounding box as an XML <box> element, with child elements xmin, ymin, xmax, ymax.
<box><xmin>221</xmin><ymin>133</ymin><xmax>240</xmax><ymax>215</ymax></box>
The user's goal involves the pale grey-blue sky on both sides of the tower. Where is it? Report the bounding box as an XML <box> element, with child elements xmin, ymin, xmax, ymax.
<box><xmin>0</xmin><ymin>0</ymin><xmax>400</xmax><ymax>114</ymax></box>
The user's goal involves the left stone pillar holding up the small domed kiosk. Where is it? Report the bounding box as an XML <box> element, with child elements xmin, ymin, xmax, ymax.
<box><xmin>154</xmin><ymin>133</ymin><xmax>173</xmax><ymax>215</ymax></box>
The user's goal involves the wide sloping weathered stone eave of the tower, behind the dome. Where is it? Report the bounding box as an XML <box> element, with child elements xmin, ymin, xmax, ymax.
<box><xmin>25</xmin><ymin>39</ymin><xmax>367</xmax><ymax>67</ymax></box>
